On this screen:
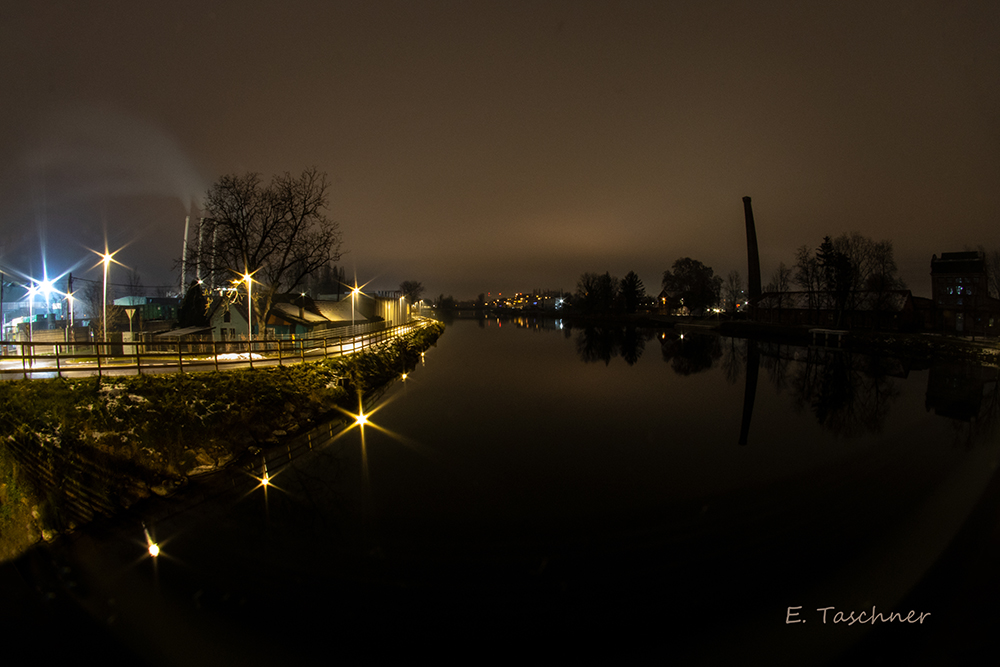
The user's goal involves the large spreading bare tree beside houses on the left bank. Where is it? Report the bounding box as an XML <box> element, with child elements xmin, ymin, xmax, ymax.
<box><xmin>187</xmin><ymin>167</ymin><xmax>342</xmax><ymax>329</ymax></box>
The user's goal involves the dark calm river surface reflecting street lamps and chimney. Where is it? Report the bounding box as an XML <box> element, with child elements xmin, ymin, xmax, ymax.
<box><xmin>0</xmin><ymin>319</ymin><xmax>1000</xmax><ymax>665</ymax></box>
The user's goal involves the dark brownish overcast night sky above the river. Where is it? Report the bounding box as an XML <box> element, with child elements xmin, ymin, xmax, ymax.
<box><xmin>0</xmin><ymin>0</ymin><xmax>1000</xmax><ymax>298</ymax></box>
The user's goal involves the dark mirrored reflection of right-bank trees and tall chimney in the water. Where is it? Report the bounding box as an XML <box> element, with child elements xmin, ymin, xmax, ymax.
<box><xmin>567</xmin><ymin>323</ymin><xmax>1000</xmax><ymax>444</ymax></box>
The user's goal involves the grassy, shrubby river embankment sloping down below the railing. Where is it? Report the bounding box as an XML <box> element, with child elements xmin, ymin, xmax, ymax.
<box><xmin>0</xmin><ymin>323</ymin><xmax>444</xmax><ymax>561</ymax></box>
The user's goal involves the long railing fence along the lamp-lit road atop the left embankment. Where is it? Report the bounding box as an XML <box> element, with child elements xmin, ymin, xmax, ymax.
<box><xmin>0</xmin><ymin>320</ymin><xmax>429</xmax><ymax>379</ymax></box>
